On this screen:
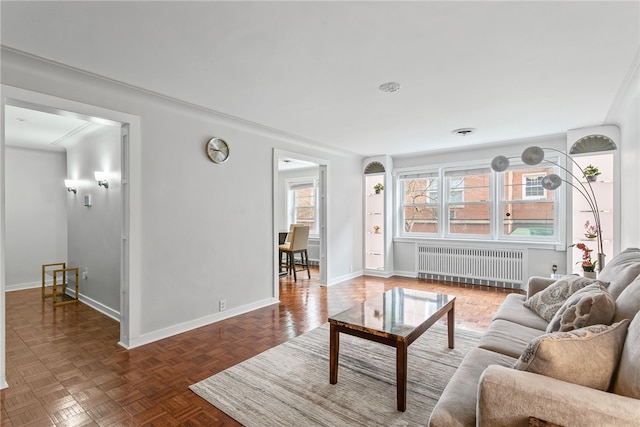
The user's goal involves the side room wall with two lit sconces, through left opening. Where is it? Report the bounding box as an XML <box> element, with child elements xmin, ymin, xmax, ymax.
<box><xmin>67</xmin><ymin>125</ymin><xmax>122</xmax><ymax>319</ymax></box>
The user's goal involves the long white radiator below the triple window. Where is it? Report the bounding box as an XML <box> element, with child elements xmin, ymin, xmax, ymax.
<box><xmin>417</xmin><ymin>244</ymin><xmax>528</xmax><ymax>289</ymax></box>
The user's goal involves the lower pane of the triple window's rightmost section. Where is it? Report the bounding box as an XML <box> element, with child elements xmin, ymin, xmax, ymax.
<box><xmin>502</xmin><ymin>202</ymin><xmax>554</xmax><ymax>237</ymax></box>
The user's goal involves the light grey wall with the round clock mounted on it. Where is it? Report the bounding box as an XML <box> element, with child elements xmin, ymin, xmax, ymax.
<box><xmin>2</xmin><ymin>47</ymin><xmax>362</xmax><ymax>345</ymax></box>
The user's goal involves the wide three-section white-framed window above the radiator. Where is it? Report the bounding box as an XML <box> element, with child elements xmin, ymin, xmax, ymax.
<box><xmin>396</xmin><ymin>164</ymin><xmax>559</xmax><ymax>243</ymax></box>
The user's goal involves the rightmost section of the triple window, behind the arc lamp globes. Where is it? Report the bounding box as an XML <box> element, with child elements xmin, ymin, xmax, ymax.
<box><xmin>500</xmin><ymin>165</ymin><xmax>556</xmax><ymax>239</ymax></box>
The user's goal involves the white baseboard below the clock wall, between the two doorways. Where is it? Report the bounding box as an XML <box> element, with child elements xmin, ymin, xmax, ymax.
<box><xmin>119</xmin><ymin>298</ymin><xmax>280</xmax><ymax>349</ymax></box>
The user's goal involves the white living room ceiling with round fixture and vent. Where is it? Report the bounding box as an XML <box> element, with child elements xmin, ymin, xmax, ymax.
<box><xmin>0</xmin><ymin>1</ymin><xmax>640</xmax><ymax>155</ymax></box>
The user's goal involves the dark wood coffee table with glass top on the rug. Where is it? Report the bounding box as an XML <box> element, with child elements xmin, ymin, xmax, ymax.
<box><xmin>329</xmin><ymin>288</ymin><xmax>456</xmax><ymax>411</ymax></box>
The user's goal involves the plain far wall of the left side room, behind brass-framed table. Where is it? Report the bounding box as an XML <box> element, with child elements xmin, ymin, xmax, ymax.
<box><xmin>5</xmin><ymin>147</ymin><xmax>67</xmax><ymax>290</ymax></box>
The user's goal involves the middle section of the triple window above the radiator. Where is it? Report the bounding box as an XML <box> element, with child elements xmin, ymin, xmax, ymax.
<box><xmin>444</xmin><ymin>168</ymin><xmax>491</xmax><ymax>236</ymax></box>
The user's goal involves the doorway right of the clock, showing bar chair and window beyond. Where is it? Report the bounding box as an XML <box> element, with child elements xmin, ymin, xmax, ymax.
<box><xmin>273</xmin><ymin>149</ymin><xmax>328</xmax><ymax>298</ymax></box>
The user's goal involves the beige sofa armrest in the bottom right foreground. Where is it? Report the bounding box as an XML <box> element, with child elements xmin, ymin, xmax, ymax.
<box><xmin>476</xmin><ymin>365</ymin><xmax>640</xmax><ymax>427</ymax></box>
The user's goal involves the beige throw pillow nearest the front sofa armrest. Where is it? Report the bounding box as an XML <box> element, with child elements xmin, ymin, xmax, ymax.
<box><xmin>514</xmin><ymin>319</ymin><xmax>629</xmax><ymax>391</ymax></box>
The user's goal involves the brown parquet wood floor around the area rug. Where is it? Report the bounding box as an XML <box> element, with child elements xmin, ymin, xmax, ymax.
<box><xmin>0</xmin><ymin>270</ymin><xmax>506</xmax><ymax>427</ymax></box>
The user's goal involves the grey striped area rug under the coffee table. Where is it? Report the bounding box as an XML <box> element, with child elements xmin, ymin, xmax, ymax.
<box><xmin>190</xmin><ymin>322</ymin><xmax>480</xmax><ymax>427</ymax></box>
